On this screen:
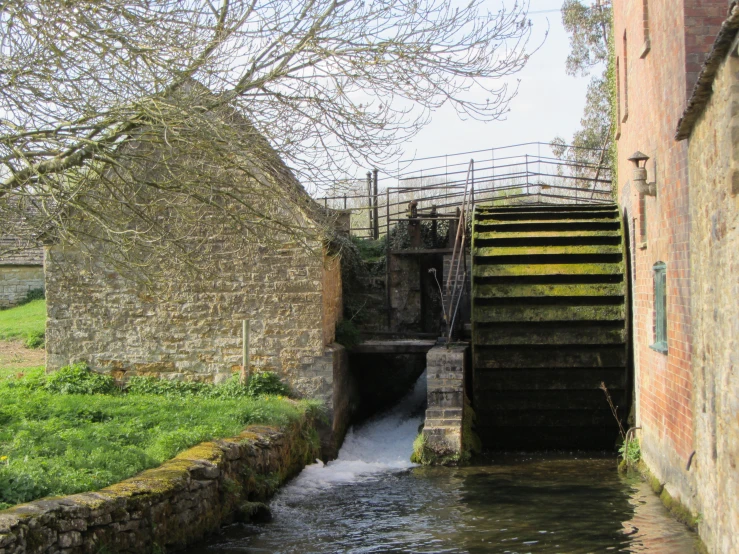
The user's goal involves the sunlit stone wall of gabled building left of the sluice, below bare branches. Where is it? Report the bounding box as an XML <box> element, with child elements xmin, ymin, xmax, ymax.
<box><xmin>46</xmin><ymin>105</ymin><xmax>351</xmax><ymax>455</ymax></box>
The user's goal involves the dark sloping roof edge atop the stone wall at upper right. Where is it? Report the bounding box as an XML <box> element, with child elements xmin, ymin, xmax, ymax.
<box><xmin>675</xmin><ymin>2</ymin><xmax>739</xmax><ymax>140</ymax></box>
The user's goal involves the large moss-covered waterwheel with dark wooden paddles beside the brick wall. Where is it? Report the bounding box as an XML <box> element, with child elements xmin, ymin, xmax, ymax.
<box><xmin>472</xmin><ymin>205</ymin><xmax>628</xmax><ymax>449</ymax></box>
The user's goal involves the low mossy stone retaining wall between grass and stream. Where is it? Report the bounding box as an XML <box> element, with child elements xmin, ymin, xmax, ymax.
<box><xmin>0</xmin><ymin>419</ymin><xmax>318</xmax><ymax>554</ymax></box>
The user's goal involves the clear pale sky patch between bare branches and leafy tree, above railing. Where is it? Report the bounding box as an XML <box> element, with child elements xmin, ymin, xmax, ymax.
<box><xmin>396</xmin><ymin>0</ymin><xmax>590</xmax><ymax>163</ymax></box>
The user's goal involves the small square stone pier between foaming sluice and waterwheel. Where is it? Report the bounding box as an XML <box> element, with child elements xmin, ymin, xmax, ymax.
<box><xmin>423</xmin><ymin>344</ymin><xmax>469</xmax><ymax>459</ymax></box>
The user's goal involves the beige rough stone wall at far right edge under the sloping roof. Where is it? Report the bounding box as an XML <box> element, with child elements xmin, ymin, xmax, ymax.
<box><xmin>689</xmin><ymin>42</ymin><xmax>739</xmax><ymax>552</ymax></box>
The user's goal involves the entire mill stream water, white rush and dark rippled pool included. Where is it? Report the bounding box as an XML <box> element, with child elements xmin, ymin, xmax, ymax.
<box><xmin>191</xmin><ymin>375</ymin><xmax>694</xmax><ymax>554</ymax></box>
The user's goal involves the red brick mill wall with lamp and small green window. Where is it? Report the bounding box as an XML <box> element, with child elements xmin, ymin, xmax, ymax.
<box><xmin>614</xmin><ymin>0</ymin><xmax>727</xmax><ymax>478</ymax></box>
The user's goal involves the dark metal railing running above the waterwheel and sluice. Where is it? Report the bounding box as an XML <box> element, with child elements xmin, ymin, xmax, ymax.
<box><xmin>317</xmin><ymin>142</ymin><xmax>612</xmax><ymax>238</ymax></box>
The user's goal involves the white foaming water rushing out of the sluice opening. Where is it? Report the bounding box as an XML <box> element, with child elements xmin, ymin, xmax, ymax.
<box><xmin>276</xmin><ymin>372</ymin><xmax>426</xmax><ymax>500</ymax></box>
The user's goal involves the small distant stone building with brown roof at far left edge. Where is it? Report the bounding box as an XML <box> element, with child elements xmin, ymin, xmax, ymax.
<box><xmin>0</xmin><ymin>237</ymin><xmax>44</xmax><ymax>308</ymax></box>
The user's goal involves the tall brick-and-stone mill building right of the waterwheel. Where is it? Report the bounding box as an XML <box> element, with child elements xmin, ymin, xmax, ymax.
<box><xmin>613</xmin><ymin>0</ymin><xmax>739</xmax><ymax>552</ymax></box>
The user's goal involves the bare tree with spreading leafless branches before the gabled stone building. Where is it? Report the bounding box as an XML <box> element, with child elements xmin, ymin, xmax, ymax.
<box><xmin>0</xmin><ymin>0</ymin><xmax>530</xmax><ymax>272</ymax></box>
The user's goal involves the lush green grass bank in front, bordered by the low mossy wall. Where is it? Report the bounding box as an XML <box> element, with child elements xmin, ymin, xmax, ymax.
<box><xmin>0</xmin><ymin>368</ymin><xmax>317</xmax><ymax>509</ymax></box>
